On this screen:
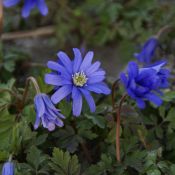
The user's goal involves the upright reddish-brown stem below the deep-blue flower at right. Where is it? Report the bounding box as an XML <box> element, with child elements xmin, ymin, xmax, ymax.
<box><xmin>116</xmin><ymin>94</ymin><xmax>127</xmax><ymax>162</ymax></box>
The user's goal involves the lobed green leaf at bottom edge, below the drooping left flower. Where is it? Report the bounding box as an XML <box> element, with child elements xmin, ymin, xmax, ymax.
<box><xmin>50</xmin><ymin>148</ymin><xmax>80</xmax><ymax>175</ymax></box>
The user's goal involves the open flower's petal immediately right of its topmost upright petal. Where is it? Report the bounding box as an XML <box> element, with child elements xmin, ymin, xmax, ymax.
<box><xmin>80</xmin><ymin>51</ymin><xmax>94</xmax><ymax>71</ymax></box>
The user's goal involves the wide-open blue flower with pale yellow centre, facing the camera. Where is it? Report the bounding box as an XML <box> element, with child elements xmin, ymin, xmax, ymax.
<box><xmin>45</xmin><ymin>48</ymin><xmax>111</xmax><ymax>116</ymax></box>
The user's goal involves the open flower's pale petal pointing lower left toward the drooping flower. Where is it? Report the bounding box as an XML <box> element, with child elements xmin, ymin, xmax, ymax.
<box><xmin>51</xmin><ymin>85</ymin><xmax>72</xmax><ymax>104</ymax></box>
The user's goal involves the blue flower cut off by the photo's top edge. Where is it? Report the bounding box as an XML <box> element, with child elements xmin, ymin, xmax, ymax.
<box><xmin>3</xmin><ymin>0</ymin><xmax>48</xmax><ymax>18</ymax></box>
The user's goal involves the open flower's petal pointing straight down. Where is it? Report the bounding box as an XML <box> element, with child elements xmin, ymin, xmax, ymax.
<box><xmin>72</xmin><ymin>86</ymin><xmax>82</xmax><ymax>117</ymax></box>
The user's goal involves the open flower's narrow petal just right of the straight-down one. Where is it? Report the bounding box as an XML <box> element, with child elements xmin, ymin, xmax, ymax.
<box><xmin>80</xmin><ymin>88</ymin><xmax>96</xmax><ymax>112</ymax></box>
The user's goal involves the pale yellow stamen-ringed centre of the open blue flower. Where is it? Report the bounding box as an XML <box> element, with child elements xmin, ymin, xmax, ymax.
<box><xmin>72</xmin><ymin>72</ymin><xmax>88</xmax><ymax>87</ymax></box>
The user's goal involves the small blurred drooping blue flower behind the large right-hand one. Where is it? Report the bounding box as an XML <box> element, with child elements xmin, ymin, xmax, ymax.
<box><xmin>134</xmin><ymin>37</ymin><xmax>158</xmax><ymax>64</ymax></box>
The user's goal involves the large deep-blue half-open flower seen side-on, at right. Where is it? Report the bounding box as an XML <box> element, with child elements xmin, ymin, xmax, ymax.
<box><xmin>120</xmin><ymin>61</ymin><xmax>170</xmax><ymax>108</ymax></box>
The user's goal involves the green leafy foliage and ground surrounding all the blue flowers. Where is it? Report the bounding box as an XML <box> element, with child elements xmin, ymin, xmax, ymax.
<box><xmin>0</xmin><ymin>0</ymin><xmax>175</xmax><ymax>175</ymax></box>
